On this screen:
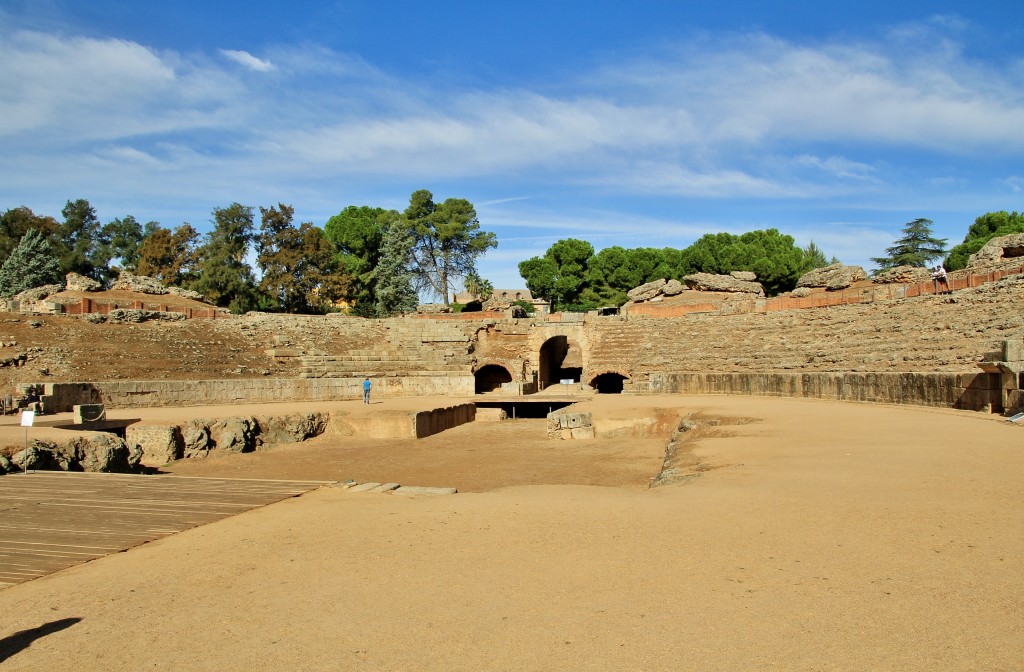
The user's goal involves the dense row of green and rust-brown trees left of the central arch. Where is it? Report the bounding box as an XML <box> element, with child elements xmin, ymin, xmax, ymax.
<box><xmin>0</xmin><ymin>190</ymin><xmax>498</xmax><ymax>317</ymax></box>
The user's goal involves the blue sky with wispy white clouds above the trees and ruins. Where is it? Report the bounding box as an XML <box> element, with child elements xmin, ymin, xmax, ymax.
<box><xmin>0</xmin><ymin>0</ymin><xmax>1024</xmax><ymax>287</ymax></box>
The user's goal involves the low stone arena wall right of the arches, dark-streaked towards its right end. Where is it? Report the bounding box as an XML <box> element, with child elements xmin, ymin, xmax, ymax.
<box><xmin>638</xmin><ymin>373</ymin><xmax>1004</xmax><ymax>413</ymax></box>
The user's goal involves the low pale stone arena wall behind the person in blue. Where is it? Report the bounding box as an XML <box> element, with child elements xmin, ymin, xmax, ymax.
<box><xmin>37</xmin><ymin>375</ymin><xmax>475</xmax><ymax>413</ymax></box>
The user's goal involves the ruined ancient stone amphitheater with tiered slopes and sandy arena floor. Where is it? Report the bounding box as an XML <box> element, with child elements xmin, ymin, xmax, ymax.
<box><xmin>0</xmin><ymin>260</ymin><xmax>1024</xmax><ymax>670</ymax></box>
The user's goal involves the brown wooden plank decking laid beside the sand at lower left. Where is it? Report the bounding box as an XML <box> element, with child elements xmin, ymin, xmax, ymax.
<box><xmin>0</xmin><ymin>471</ymin><xmax>327</xmax><ymax>588</ymax></box>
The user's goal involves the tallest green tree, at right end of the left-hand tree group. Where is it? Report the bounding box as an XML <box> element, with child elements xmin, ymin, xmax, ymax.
<box><xmin>404</xmin><ymin>190</ymin><xmax>498</xmax><ymax>305</ymax></box>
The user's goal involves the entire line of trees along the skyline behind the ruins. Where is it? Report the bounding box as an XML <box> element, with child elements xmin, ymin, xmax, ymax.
<box><xmin>0</xmin><ymin>194</ymin><xmax>1024</xmax><ymax>318</ymax></box>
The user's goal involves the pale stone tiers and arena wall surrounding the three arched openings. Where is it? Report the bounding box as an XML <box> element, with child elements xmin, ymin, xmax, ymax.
<box><xmin>29</xmin><ymin>278</ymin><xmax>1024</xmax><ymax>410</ymax></box>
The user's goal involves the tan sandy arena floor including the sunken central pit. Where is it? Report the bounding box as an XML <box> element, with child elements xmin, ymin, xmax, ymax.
<box><xmin>0</xmin><ymin>396</ymin><xmax>1024</xmax><ymax>671</ymax></box>
